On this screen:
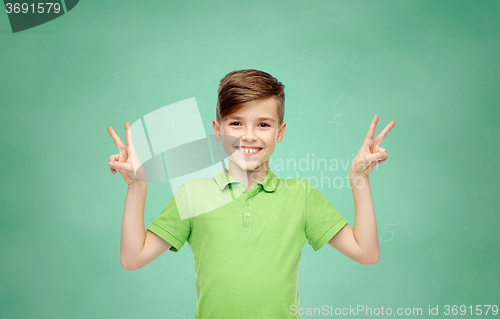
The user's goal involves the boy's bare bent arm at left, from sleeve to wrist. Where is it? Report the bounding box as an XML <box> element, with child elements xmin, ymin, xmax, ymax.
<box><xmin>120</xmin><ymin>181</ymin><xmax>172</xmax><ymax>270</ymax></box>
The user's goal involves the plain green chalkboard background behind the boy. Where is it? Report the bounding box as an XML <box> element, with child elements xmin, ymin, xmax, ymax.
<box><xmin>0</xmin><ymin>0</ymin><xmax>500</xmax><ymax>319</ymax></box>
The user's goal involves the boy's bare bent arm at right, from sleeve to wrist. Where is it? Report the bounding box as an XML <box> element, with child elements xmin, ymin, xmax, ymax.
<box><xmin>328</xmin><ymin>175</ymin><xmax>379</xmax><ymax>265</ymax></box>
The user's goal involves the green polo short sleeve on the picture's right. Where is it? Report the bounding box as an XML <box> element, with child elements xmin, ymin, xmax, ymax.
<box><xmin>304</xmin><ymin>180</ymin><xmax>347</xmax><ymax>251</ymax></box>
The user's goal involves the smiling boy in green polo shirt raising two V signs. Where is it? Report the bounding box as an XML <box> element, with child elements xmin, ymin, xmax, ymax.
<box><xmin>108</xmin><ymin>69</ymin><xmax>395</xmax><ymax>319</ymax></box>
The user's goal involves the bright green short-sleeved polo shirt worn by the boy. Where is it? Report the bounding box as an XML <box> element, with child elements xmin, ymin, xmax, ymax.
<box><xmin>147</xmin><ymin>169</ymin><xmax>347</xmax><ymax>319</ymax></box>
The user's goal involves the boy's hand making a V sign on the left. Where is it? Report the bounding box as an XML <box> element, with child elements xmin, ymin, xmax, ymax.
<box><xmin>108</xmin><ymin>121</ymin><xmax>147</xmax><ymax>185</ymax></box>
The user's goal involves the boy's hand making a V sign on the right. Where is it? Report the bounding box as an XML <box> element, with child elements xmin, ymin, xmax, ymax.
<box><xmin>351</xmin><ymin>115</ymin><xmax>396</xmax><ymax>177</ymax></box>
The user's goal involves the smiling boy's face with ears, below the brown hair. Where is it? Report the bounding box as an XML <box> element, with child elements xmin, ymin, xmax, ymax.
<box><xmin>213</xmin><ymin>97</ymin><xmax>286</xmax><ymax>170</ymax></box>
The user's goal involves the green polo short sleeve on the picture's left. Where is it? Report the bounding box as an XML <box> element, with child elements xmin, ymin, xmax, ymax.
<box><xmin>147</xmin><ymin>184</ymin><xmax>191</xmax><ymax>252</ymax></box>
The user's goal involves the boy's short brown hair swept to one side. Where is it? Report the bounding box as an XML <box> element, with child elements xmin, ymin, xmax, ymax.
<box><xmin>216</xmin><ymin>69</ymin><xmax>285</xmax><ymax>125</ymax></box>
